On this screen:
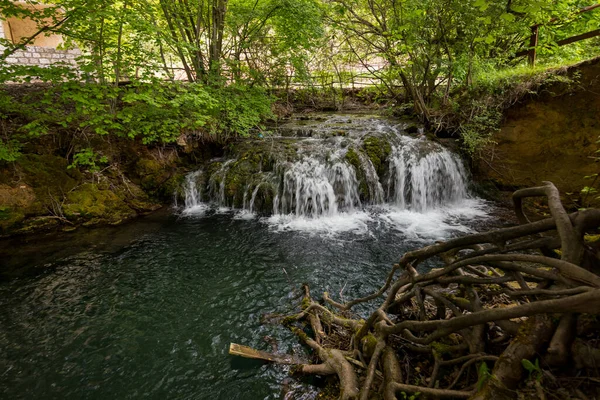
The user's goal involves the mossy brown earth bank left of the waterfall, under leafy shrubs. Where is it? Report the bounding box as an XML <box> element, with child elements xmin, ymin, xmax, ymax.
<box><xmin>0</xmin><ymin>141</ymin><xmax>192</xmax><ymax>237</ymax></box>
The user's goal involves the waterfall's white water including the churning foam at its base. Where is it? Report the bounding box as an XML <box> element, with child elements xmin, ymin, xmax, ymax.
<box><xmin>176</xmin><ymin>117</ymin><xmax>487</xmax><ymax>240</ymax></box>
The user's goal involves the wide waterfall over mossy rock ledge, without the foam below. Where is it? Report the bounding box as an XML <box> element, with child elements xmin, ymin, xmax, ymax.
<box><xmin>178</xmin><ymin>117</ymin><xmax>478</xmax><ymax>225</ymax></box>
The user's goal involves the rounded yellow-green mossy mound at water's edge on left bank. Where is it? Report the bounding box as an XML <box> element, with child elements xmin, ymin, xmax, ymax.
<box><xmin>63</xmin><ymin>183</ymin><xmax>137</xmax><ymax>225</ymax></box>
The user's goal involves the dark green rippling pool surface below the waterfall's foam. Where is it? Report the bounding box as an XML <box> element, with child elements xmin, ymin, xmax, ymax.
<box><xmin>0</xmin><ymin>206</ymin><xmax>488</xmax><ymax>399</ymax></box>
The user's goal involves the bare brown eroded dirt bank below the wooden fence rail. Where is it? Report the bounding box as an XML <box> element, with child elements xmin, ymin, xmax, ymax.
<box><xmin>476</xmin><ymin>58</ymin><xmax>600</xmax><ymax>205</ymax></box>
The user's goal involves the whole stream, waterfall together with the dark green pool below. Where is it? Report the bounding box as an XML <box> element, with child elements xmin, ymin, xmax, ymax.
<box><xmin>0</xmin><ymin>115</ymin><xmax>493</xmax><ymax>399</ymax></box>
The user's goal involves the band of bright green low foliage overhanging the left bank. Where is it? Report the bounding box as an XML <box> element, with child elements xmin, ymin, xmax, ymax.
<box><xmin>0</xmin><ymin>67</ymin><xmax>273</xmax><ymax>148</ymax></box>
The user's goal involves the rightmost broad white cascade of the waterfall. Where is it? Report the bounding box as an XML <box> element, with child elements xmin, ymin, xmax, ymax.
<box><xmin>387</xmin><ymin>137</ymin><xmax>468</xmax><ymax>212</ymax></box>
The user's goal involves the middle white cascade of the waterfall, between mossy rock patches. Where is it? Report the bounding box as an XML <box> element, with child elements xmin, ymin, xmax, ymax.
<box><xmin>273</xmin><ymin>157</ymin><xmax>360</xmax><ymax>217</ymax></box>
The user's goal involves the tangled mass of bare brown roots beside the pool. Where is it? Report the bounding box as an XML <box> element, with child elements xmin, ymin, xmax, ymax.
<box><xmin>231</xmin><ymin>182</ymin><xmax>600</xmax><ymax>400</ymax></box>
